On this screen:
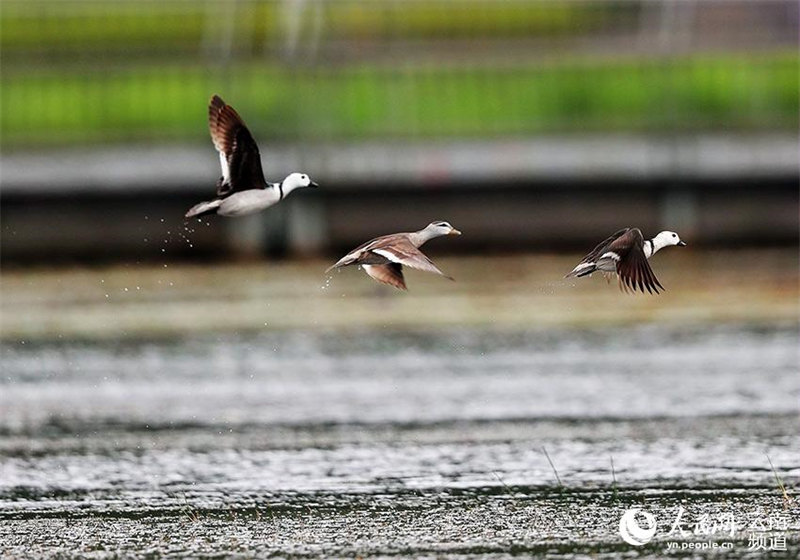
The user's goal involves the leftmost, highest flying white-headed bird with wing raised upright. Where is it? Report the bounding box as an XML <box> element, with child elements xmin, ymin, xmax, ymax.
<box><xmin>185</xmin><ymin>95</ymin><xmax>318</xmax><ymax>218</ymax></box>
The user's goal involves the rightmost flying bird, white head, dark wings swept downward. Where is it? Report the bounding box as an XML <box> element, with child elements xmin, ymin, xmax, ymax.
<box><xmin>565</xmin><ymin>228</ymin><xmax>686</xmax><ymax>294</ymax></box>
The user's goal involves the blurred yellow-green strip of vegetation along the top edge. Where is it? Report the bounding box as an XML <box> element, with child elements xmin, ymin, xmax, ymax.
<box><xmin>0</xmin><ymin>0</ymin><xmax>640</xmax><ymax>54</ymax></box>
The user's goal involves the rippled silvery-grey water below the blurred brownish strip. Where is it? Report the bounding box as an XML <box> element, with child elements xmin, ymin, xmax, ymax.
<box><xmin>0</xmin><ymin>326</ymin><xmax>800</xmax><ymax>558</ymax></box>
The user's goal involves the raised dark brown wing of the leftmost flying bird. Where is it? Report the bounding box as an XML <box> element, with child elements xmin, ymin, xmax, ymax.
<box><xmin>208</xmin><ymin>95</ymin><xmax>267</xmax><ymax>196</ymax></box>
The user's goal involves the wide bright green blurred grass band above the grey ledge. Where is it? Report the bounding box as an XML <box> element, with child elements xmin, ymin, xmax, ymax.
<box><xmin>0</xmin><ymin>53</ymin><xmax>798</xmax><ymax>148</ymax></box>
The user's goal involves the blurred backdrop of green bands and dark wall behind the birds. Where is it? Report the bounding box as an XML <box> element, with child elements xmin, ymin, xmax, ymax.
<box><xmin>0</xmin><ymin>0</ymin><xmax>798</xmax><ymax>264</ymax></box>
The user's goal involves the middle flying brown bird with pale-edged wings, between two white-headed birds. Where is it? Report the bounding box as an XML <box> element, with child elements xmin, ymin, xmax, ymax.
<box><xmin>325</xmin><ymin>221</ymin><xmax>461</xmax><ymax>290</ymax></box>
